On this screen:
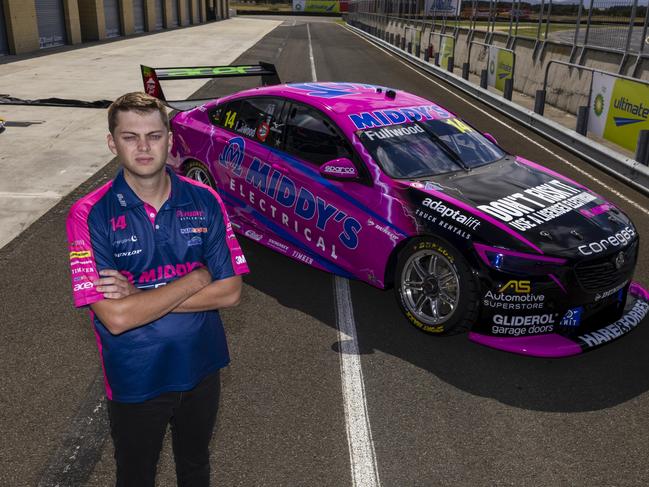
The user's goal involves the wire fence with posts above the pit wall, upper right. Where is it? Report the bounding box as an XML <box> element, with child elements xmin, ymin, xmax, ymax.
<box><xmin>349</xmin><ymin>0</ymin><xmax>649</xmax><ymax>55</ymax></box>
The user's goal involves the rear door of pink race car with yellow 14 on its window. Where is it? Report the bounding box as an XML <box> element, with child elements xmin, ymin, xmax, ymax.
<box><xmin>209</xmin><ymin>97</ymin><xmax>283</xmax><ymax>229</ymax></box>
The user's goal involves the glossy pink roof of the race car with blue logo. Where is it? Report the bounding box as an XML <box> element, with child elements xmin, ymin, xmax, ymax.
<box><xmin>210</xmin><ymin>82</ymin><xmax>452</xmax><ymax>137</ymax></box>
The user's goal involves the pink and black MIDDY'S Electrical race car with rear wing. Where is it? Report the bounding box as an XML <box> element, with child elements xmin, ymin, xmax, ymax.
<box><xmin>142</xmin><ymin>63</ymin><xmax>649</xmax><ymax>357</ymax></box>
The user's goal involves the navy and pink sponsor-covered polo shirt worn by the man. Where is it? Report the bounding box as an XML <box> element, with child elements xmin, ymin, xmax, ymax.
<box><xmin>66</xmin><ymin>169</ymin><xmax>248</xmax><ymax>402</ymax></box>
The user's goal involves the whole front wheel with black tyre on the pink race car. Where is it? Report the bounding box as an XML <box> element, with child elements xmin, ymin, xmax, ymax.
<box><xmin>394</xmin><ymin>237</ymin><xmax>479</xmax><ymax>335</ymax></box>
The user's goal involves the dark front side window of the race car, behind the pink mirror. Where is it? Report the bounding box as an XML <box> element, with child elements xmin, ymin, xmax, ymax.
<box><xmin>286</xmin><ymin>104</ymin><xmax>353</xmax><ymax>165</ymax></box>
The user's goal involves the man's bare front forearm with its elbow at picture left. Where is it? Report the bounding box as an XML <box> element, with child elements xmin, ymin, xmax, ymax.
<box><xmin>90</xmin><ymin>268</ymin><xmax>212</xmax><ymax>335</ymax></box>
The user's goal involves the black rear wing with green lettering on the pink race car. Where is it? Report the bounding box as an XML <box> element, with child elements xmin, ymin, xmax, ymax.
<box><xmin>140</xmin><ymin>61</ymin><xmax>281</xmax><ymax>111</ymax></box>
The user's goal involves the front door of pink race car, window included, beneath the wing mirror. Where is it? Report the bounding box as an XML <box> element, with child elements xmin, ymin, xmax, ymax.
<box><xmin>269</xmin><ymin>102</ymin><xmax>399</xmax><ymax>283</ymax></box>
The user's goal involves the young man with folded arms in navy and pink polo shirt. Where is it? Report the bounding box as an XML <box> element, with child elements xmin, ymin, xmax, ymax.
<box><xmin>67</xmin><ymin>93</ymin><xmax>248</xmax><ymax>487</ymax></box>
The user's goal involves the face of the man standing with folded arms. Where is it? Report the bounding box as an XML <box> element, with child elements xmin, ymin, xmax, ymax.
<box><xmin>108</xmin><ymin>110</ymin><xmax>171</xmax><ymax>178</ymax></box>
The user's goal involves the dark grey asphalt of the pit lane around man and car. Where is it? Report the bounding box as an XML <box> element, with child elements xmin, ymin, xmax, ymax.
<box><xmin>0</xmin><ymin>18</ymin><xmax>649</xmax><ymax>486</ymax></box>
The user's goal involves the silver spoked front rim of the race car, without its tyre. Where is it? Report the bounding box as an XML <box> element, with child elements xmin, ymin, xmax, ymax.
<box><xmin>400</xmin><ymin>249</ymin><xmax>460</xmax><ymax>325</ymax></box>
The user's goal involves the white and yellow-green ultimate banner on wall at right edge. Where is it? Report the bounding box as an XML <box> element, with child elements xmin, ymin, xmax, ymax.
<box><xmin>588</xmin><ymin>73</ymin><xmax>649</xmax><ymax>151</ymax></box>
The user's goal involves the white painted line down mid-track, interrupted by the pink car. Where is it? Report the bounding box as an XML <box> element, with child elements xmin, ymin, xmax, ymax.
<box><xmin>306</xmin><ymin>23</ymin><xmax>381</xmax><ymax>487</ymax></box>
